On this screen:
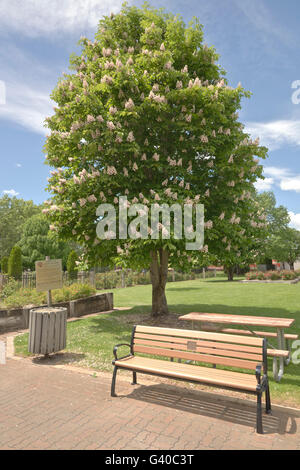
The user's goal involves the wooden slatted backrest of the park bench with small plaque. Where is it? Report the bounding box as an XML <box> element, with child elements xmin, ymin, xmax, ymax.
<box><xmin>132</xmin><ymin>325</ymin><xmax>267</xmax><ymax>372</ymax></box>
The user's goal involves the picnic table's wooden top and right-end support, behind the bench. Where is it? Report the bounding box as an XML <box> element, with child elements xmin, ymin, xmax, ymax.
<box><xmin>179</xmin><ymin>312</ymin><xmax>295</xmax><ymax>382</ymax></box>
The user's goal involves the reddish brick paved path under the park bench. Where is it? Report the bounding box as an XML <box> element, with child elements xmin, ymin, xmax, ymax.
<box><xmin>0</xmin><ymin>359</ymin><xmax>300</xmax><ymax>450</ymax></box>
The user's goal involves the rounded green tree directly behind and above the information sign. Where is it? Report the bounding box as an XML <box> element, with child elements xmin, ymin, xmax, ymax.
<box><xmin>18</xmin><ymin>214</ymin><xmax>72</xmax><ymax>270</ymax></box>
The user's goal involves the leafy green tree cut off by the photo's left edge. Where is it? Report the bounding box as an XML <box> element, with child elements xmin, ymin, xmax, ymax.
<box><xmin>0</xmin><ymin>195</ymin><xmax>41</xmax><ymax>258</ymax></box>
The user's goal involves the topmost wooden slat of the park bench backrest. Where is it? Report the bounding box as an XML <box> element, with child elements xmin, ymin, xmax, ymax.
<box><xmin>136</xmin><ymin>325</ymin><xmax>263</xmax><ymax>347</ymax></box>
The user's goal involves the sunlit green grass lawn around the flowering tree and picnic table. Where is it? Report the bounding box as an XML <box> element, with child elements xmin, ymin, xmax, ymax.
<box><xmin>15</xmin><ymin>276</ymin><xmax>300</xmax><ymax>407</ymax></box>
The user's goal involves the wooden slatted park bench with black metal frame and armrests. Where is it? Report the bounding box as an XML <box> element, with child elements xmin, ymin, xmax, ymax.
<box><xmin>111</xmin><ymin>325</ymin><xmax>271</xmax><ymax>434</ymax></box>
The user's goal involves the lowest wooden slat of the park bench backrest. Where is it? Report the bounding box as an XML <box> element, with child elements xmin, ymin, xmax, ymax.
<box><xmin>133</xmin><ymin>345</ymin><xmax>257</xmax><ymax>370</ymax></box>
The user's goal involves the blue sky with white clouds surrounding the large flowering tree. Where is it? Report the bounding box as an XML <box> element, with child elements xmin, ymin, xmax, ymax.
<box><xmin>0</xmin><ymin>0</ymin><xmax>300</xmax><ymax>230</ymax></box>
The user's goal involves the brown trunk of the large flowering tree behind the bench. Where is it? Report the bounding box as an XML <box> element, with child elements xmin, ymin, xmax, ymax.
<box><xmin>150</xmin><ymin>248</ymin><xmax>169</xmax><ymax>317</ymax></box>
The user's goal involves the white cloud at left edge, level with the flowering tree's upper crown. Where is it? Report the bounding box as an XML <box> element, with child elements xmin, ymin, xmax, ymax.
<box><xmin>0</xmin><ymin>83</ymin><xmax>53</xmax><ymax>135</ymax></box>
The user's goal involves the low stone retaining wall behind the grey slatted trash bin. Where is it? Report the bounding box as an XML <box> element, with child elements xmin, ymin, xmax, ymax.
<box><xmin>0</xmin><ymin>292</ymin><xmax>114</xmax><ymax>333</ymax></box>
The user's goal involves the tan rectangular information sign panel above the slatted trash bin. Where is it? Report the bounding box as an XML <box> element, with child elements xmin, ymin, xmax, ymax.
<box><xmin>35</xmin><ymin>259</ymin><xmax>63</xmax><ymax>292</ymax></box>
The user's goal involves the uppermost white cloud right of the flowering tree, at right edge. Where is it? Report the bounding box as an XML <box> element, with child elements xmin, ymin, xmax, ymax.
<box><xmin>245</xmin><ymin>120</ymin><xmax>300</xmax><ymax>150</ymax></box>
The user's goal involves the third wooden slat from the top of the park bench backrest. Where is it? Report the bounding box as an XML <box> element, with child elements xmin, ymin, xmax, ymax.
<box><xmin>134</xmin><ymin>338</ymin><xmax>262</xmax><ymax>362</ymax></box>
